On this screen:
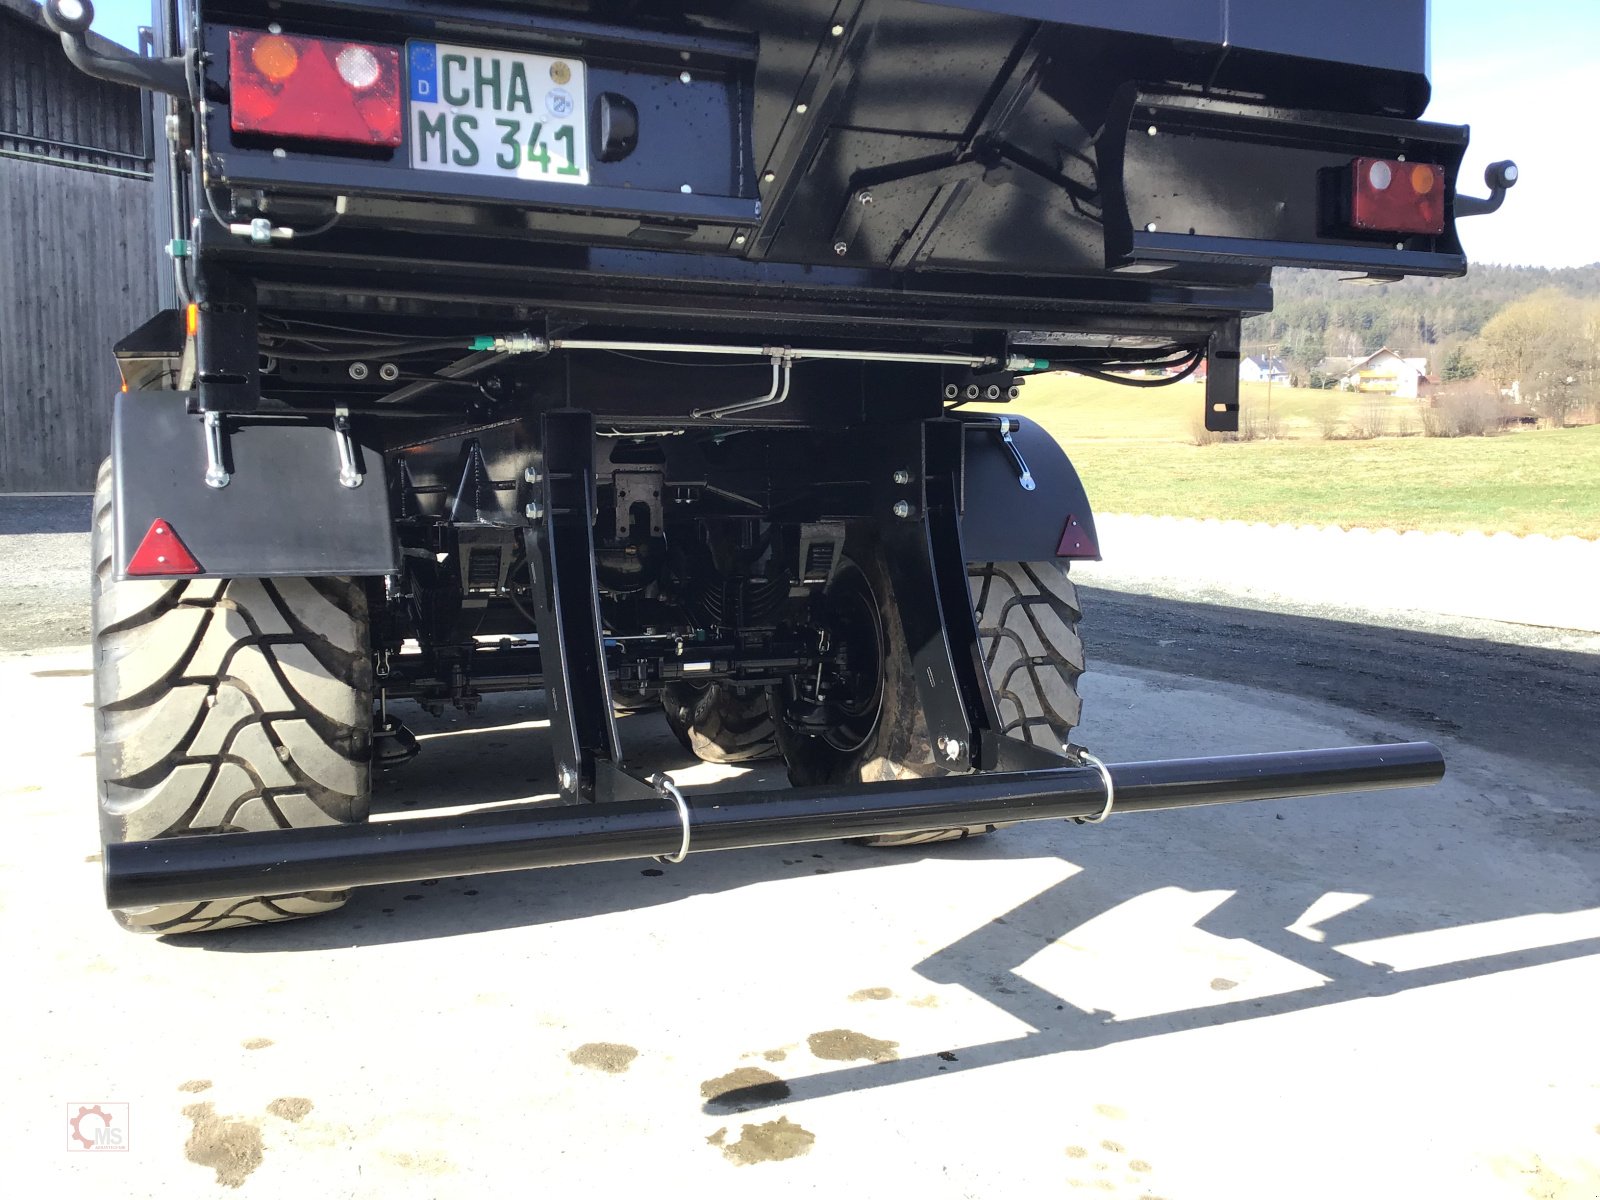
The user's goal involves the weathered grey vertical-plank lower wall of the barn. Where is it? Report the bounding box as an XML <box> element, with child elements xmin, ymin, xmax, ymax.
<box><xmin>0</xmin><ymin>157</ymin><xmax>165</xmax><ymax>491</ymax></box>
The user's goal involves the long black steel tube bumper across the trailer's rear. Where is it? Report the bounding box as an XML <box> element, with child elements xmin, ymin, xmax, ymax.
<box><xmin>104</xmin><ymin>742</ymin><xmax>1445</xmax><ymax>909</ymax></box>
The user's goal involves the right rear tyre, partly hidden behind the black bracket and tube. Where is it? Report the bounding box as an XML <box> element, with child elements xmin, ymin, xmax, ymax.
<box><xmin>779</xmin><ymin>549</ymin><xmax>1083</xmax><ymax>846</ymax></box>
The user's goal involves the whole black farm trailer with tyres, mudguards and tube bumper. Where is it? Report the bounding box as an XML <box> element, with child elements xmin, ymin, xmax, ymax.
<box><xmin>46</xmin><ymin>0</ymin><xmax>1515</xmax><ymax>933</ymax></box>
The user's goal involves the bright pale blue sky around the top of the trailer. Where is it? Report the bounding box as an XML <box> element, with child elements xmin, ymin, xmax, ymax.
<box><xmin>68</xmin><ymin>0</ymin><xmax>1600</xmax><ymax>267</ymax></box>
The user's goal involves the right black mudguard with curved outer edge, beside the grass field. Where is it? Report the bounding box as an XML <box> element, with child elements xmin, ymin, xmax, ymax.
<box><xmin>962</xmin><ymin>413</ymin><xmax>1101</xmax><ymax>563</ymax></box>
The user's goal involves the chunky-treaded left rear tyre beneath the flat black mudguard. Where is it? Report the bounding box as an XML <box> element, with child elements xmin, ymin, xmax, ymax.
<box><xmin>91</xmin><ymin>462</ymin><xmax>373</xmax><ymax>934</ymax></box>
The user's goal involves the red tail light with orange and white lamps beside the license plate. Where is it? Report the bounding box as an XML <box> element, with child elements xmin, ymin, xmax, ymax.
<box><xmin>227</xmin><ymin>29</ymin><xmax>402</xmax><ymax>146</ymax></box>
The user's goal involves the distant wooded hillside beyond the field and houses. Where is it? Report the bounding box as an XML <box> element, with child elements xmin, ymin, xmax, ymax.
<box><xmin>1243</xmin><ymin>262</ymin><xmax>1600</xmax><ymax>374</ymax></box>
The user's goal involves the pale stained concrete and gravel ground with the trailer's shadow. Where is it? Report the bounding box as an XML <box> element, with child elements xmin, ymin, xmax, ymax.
<box><xmin>0</xmin><ymin>496</ymin><xmax>1600</xmax><ymax>1200</ymax></box>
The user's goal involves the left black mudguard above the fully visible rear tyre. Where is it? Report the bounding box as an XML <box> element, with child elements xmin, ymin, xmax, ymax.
<box><xmin>112</xmin><ymin>392</ymin><xmax>400</xmax><ymax>579</ymax></box>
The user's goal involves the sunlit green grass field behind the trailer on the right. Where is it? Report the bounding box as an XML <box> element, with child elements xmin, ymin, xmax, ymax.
<box><xmin>998</xmin><ymin>376</ymin><xmax>1600</xmax><ymax>538</ymax></box>
